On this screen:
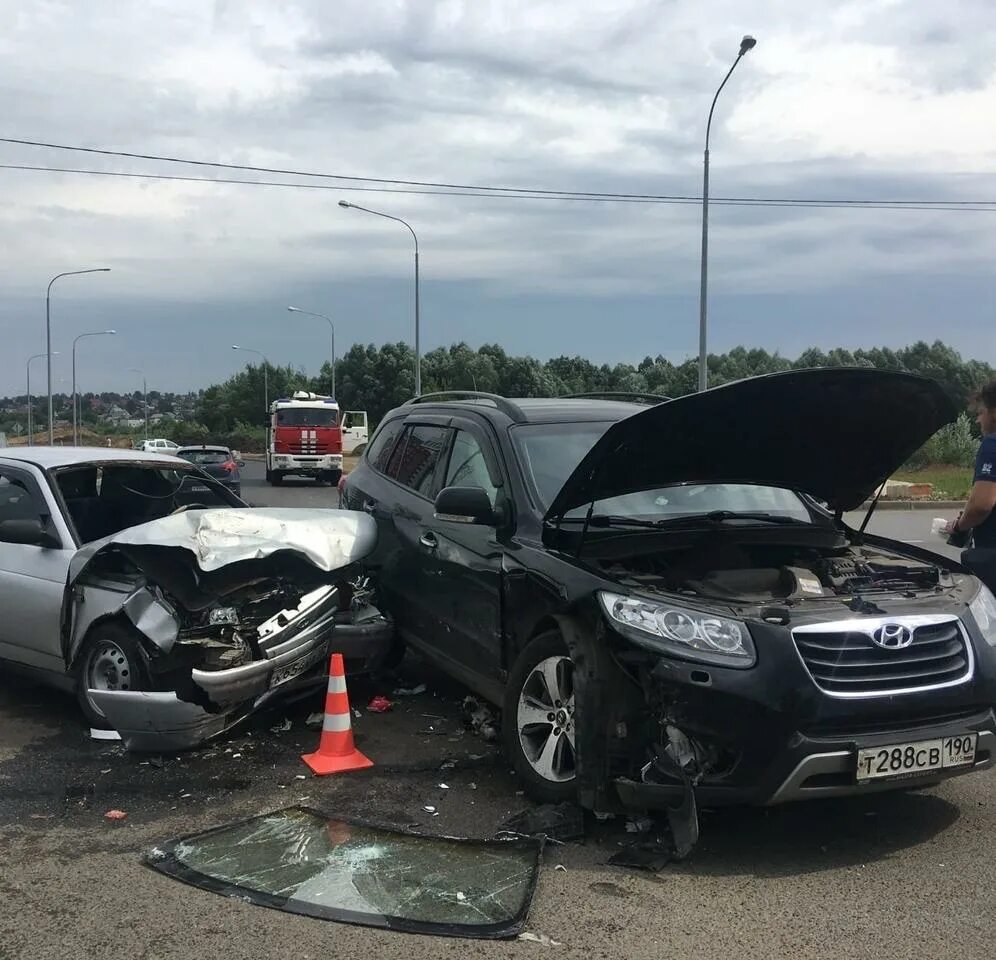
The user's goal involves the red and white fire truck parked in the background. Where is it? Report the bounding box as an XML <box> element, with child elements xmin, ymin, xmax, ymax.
<box><xmin>266</xmin><ymin>390</ymin><xmax>342</xmax><ymax>486</ymax></box>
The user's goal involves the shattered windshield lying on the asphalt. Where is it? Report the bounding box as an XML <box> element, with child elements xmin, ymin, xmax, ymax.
<box><xmin>147</xmin><ymin>807</ymin><xmax>542</xmax><ymax>937</ymax></box>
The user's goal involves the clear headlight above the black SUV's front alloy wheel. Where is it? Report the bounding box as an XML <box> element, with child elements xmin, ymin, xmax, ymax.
<box><xmin>598</xmin><ymin>590</ymin><xmax>756</xmax><ymax>667</ymax></box>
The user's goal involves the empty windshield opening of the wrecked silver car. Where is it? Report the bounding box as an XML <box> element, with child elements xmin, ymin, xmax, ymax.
<box><xmin>56</xmin><ymin>463</ymin><xmax>243</xmax><ymax>543</ymax></box>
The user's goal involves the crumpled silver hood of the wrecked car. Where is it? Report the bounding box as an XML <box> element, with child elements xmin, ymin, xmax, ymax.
<box><xmin>69</xmin><ymin>507</ymin><xmax>377</xmax><ymax>586</ymax></box>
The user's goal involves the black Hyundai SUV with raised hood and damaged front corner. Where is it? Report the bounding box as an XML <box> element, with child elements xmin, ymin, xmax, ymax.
<box><xmin>343</xmin><ymin>369</ymin><xmax>996</xmax><ymax>822</ymax></box>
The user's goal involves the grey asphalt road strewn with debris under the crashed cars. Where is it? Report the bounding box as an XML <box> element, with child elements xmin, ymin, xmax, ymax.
<box><xmin>0</xmin><ymin>465</ymin><xmax>996</xmax><ymax>960</ymax></box>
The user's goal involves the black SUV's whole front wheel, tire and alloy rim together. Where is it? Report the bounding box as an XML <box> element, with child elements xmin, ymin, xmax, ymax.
<box><xmin>502</xmin><ymin>630</ymin><xmax>577</xmax><ymax>803</ymax></box>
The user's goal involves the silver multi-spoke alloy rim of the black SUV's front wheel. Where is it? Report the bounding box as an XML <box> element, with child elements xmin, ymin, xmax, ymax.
<box><xmin>517</xmin><ymin>656</ymin><xmax>577</xmax><ymax>783</ymax></box>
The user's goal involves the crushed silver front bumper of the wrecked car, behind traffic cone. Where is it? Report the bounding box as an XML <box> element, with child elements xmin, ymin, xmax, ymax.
<box><xmin>90</xmin><ymin>588</ymin><xmax>394</xmax><ymax>751</ymax></box>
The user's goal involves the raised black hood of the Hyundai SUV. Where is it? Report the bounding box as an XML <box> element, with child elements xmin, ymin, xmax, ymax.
<box><xmin>546</xmin><ymin>368</ymin><xmax>958</xmax><ymax>520</ymax></box>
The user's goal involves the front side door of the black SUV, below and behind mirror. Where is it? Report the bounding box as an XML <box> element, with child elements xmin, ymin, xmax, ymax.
<box><xmin>422</xmin><ymin>419</ymin><xmax>504</xmax><ymax>681</ymax></box>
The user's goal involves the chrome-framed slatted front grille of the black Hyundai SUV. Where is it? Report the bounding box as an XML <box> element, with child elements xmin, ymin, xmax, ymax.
<box><xmin>792</xmin><ymin>615</ymin><xmax>975</xmax><ymax>698</ymax></box>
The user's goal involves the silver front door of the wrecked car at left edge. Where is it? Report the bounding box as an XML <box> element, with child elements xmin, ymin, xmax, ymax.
<box><xmin>0</xmin><ymin>464</ymin><xmax>76</xmax><ymax>675</ymax></box>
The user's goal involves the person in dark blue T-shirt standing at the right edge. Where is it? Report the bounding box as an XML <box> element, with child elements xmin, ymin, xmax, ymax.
<box><xmin>948</xmin><ymin>380</ymin><xmax>996</xmax><ymax>592</ymax></box>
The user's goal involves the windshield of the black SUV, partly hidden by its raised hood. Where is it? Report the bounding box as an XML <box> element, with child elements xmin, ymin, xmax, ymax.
<box><xmin>511</xmin><ymin>422</ymin><xmax>812</xmax><ymax>523</ymax></box>
